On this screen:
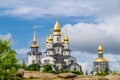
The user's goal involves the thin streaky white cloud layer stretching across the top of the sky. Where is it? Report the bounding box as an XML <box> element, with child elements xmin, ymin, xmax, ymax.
<box><xmin>0</xmin><ymin>0</ymin><xmax>120</xmax><ymax>19</ymax></box>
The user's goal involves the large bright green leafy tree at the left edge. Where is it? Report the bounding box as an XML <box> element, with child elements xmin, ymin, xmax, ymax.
<box><xmin>0</xmin><ymin>39</ymin><xmax>18</xmax><ymax>80</ymax></box>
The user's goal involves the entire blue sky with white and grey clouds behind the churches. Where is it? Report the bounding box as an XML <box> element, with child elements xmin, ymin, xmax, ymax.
<box><xmin>0</xmin><ymin>0</ymin><xmax>120</xmax><ymax>71</ymax></box>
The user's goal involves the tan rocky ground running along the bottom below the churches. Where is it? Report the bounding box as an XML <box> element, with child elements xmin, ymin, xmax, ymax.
<box><xmin>18</xmin><ymin>71</ymin><xmax>120</xmax><ymax>80</ymax></box>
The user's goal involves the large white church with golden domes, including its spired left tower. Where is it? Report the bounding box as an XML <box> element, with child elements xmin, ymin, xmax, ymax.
<box><xmin>27</xmin><ymin>20</ymin><xmax>80</xmax><ymax>71</ymax></box>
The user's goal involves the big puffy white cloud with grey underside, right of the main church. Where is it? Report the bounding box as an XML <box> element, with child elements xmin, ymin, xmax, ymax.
<box><xmin>62</xmin><ymin>16</ymin><xmax>120</xmax><ymax>54</ymax></box>
